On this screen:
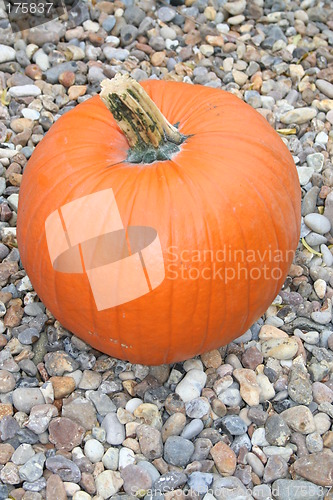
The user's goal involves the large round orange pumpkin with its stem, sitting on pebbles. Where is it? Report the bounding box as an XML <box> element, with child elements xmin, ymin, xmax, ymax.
<box><xmin>17</xmin><ymin>76</ymin><xmax>301</xmax><ymax>365</ymax></box>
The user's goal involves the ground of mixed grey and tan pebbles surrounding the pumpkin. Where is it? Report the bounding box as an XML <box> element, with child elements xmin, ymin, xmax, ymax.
<box><xmin>0</xmin><ymin>0</ymin><xmax>333</xmax><ymax>500</ymax></box>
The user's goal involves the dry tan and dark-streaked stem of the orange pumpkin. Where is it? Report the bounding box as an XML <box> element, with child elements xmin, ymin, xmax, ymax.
<box><xmin>100</xmin><ymin>74</ymin><xmax>186</xmax><ymax>163</ymax></box>
